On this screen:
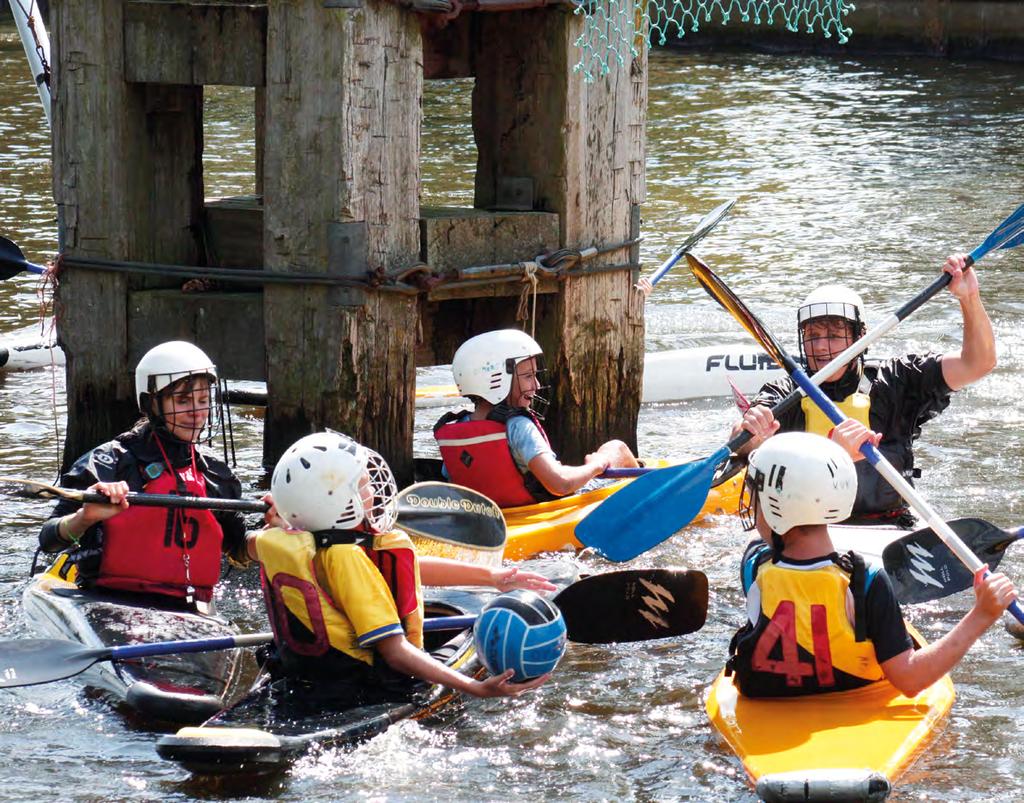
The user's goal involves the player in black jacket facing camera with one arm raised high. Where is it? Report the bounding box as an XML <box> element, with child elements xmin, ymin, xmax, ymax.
<box><xmin>732</xmin><ymin>255</ymin><xmax>995</xmax><ymax>526</ymax></box>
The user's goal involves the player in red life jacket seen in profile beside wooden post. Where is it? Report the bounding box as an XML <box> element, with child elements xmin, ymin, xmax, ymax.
<box><xmin>434</xmin><ymin>329</ymin><xmax>640</xmax><ymax>507</ymax></box>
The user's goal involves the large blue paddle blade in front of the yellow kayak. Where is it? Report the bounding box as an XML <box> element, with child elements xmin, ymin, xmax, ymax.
<box><xmin>575</xmin><ymin>447</ymin><xmax>729</xmax><ymax>562</ymax></box>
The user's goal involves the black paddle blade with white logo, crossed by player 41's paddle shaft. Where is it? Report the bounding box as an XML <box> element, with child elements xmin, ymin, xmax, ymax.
<box><xmin>882</xmin><ymin>518</ymin><xmax>1024</xmax><ymax>603</ymax></box>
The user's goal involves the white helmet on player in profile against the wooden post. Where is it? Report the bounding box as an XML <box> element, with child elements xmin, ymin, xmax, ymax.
<box><xmin>452</xmin><ymin>329</ymin><xmax>544</xmax><ymax>405</ymax></box>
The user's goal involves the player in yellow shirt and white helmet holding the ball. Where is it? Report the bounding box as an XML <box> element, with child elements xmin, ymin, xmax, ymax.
<box><xmin>248</xmin><ymin>431</ymin><xmax>555</xmax><ymax>699</ymax></box>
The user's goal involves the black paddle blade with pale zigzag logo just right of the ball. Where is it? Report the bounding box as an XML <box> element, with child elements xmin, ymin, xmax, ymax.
<box><xmin>554</xmin><ymin>568</ymin><xmax>708</xmax><ymax>644</ymax></box>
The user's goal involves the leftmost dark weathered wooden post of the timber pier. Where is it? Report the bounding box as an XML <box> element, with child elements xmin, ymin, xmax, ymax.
<box><xmin>52</xmin><ymin>0</ymin><xmax>203</xmax><ymax>465</ymax></box>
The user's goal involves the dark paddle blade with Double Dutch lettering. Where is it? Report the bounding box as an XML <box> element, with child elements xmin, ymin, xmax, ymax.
<box><xmin>398</xmin><ymin>482</ymin><xmax>505</xmax><ymax>551</ymax></box>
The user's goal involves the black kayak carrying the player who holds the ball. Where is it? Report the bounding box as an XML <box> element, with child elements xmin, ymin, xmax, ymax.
<box><xmin>157</xmin><ymin>589</ymin><xmax>493</xmax><ymax>776</ymax></box>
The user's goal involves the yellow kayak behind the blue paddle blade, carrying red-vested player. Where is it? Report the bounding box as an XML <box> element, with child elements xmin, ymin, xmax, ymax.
<box><xmin>503</xmin><ymin>461</ymin><xmax>743</xmax><ymax>560</ymax></box>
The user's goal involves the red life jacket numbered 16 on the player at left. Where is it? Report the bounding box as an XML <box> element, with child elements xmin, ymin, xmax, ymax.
<box><xmin>95</xmin><ymin>452</ymin><xmax>224</xmax><ymax>602</ymax></box>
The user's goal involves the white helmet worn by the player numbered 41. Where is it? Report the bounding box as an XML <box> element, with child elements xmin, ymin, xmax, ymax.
<box><xmin>739</xmin><ymin>432</ymin><xmax>857</xmax><ymax>536</ymax></box>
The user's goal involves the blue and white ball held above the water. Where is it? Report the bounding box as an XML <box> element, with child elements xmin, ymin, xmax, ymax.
<box><xmin>473</xmin><ymin>589</ymin><xmax>565</xmax><ymax>683</ymax></box>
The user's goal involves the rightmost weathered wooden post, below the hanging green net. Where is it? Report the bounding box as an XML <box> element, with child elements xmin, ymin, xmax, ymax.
<box><xmin>473</xmin><ymin>8</ymin><xmax>647</xmax><ymax>460</ymax></box>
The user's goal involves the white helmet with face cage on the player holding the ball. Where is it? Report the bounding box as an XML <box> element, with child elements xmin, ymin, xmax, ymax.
<box><xmin>270</xmin><ymin>429</ymin><xmax>398</xmax><ymax>533</ymax></box>
